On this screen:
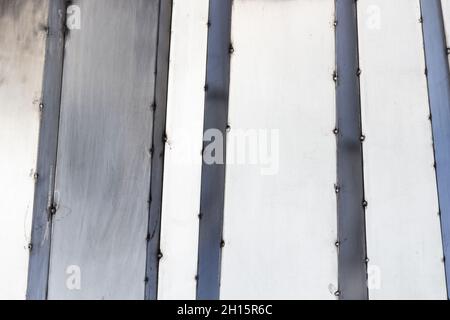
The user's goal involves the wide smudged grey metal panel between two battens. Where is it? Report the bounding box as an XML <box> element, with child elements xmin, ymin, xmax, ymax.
<box><xmin>48</xmin><ymin>0</ymin><xmax>159</xmax><ymax>299</ymax></box>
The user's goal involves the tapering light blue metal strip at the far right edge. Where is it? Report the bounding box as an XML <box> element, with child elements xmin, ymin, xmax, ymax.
<box><xmin>420</xmin><ymin>0</ymin><xmax>450</xmax><ymax>297</ymax></box>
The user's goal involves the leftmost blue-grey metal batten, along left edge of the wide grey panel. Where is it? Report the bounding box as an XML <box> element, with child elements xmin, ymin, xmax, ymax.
<box><xmin>27</xmin><ymin>0</ymin><xmax>66</xmax><ymax>300</ymax></box>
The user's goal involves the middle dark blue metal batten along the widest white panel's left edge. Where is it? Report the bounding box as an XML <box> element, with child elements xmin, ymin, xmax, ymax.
<box><xmin>197</xmin><ymin>0</ymin><xmax>232</xmax><ymax>300</ymax></box>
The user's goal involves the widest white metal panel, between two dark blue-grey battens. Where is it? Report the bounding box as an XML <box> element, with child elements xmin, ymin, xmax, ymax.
<box><xmin>221</xmin><ymin>0</ymin><xmax>337</xmax><ymax>299</ymax></box>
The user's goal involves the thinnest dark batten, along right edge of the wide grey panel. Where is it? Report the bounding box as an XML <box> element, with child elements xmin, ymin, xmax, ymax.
<box><xmin>145</xmin><ymin>0</ymin><xmax>172</xmax><ymax>300</ymax></box>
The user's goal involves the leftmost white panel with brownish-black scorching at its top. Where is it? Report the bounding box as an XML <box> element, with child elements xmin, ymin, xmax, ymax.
<box><xmin>0</xmin><ymin>0</ymin><xmax>48</xmax><ymax>299</ymax></box>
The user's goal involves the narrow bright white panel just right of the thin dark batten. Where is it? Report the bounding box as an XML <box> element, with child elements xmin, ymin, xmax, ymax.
<box><xmin>158</xmin><ymin>0</ymin><xmax>209</xmax><ymax>299</ymax></box>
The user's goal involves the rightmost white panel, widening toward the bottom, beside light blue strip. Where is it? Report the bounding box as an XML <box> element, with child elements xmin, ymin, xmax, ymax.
<box><xmin>358</xmin><ymin>0</ymin><xmax>446</xmax><ymax>299</ymax></box>
